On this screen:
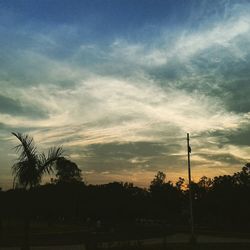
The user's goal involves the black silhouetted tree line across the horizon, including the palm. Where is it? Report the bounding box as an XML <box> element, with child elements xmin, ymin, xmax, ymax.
<box><xmin>0</xmin><ymin>133</ymin><xmax>250</xmax><ymax>231</ymax></box>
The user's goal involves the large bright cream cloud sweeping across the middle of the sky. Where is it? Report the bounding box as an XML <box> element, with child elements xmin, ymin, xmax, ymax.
<box><xmin>2</xmin><ymin>73</ymin><xmax>241</xmax><ymax>146</ymax></box>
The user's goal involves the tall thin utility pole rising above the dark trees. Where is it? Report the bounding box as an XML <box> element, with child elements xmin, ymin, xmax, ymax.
<box><xmin>187</xmin><ymin>133</ymin><xmax>195</xmax><ymax>243</ymax></box>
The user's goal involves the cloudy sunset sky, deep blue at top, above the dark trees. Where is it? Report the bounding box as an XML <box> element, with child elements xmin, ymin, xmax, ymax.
<box><xmin>0</xmin><ymin>0</ymin><xmax>250</xmax><ymax>188</ymax></box>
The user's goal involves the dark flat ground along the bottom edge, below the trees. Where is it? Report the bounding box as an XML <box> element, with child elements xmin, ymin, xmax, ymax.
<box><xmin>0</xmin><ymin>221</ymin><xmax>250</xmax><ymax>250</ymax></box>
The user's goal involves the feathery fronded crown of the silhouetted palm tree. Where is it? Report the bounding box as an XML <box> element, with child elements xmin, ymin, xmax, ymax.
<box><xmin>12</xmin><ymin>133</ymin><xmax>63</xmax><ymax>189</ymax></box>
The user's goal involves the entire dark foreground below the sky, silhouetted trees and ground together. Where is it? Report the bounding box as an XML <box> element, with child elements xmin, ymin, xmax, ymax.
<box><xmin>0</xmin><ymin>134</ymin><xmax>250</xmax><ymax>250</ymax></box>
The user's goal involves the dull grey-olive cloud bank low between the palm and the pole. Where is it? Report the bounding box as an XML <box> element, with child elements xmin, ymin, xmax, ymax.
<box><xmin>70</xmin><ymin>141</ymin><xmax>186</xmax><ymax>182</ymax></box>
